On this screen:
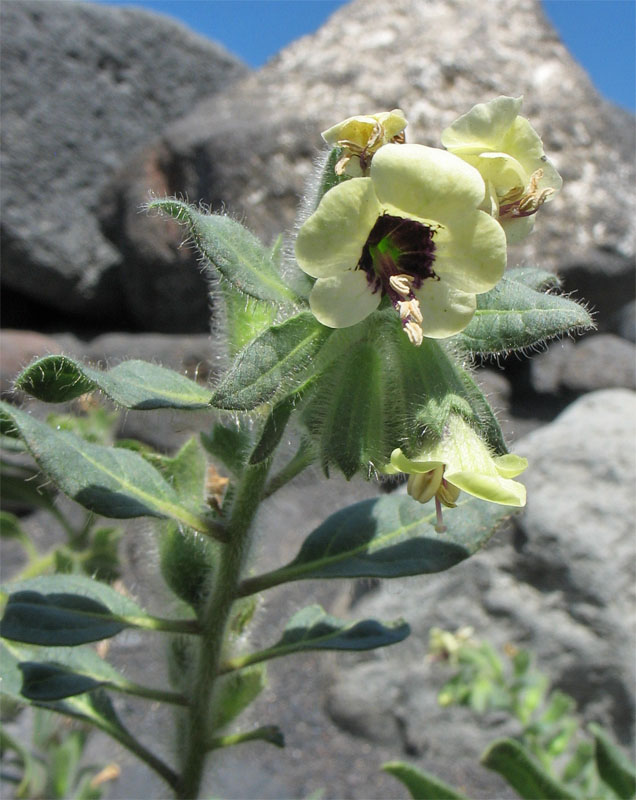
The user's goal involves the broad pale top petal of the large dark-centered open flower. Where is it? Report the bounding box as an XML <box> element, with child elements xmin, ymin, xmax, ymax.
<box><xmin>371</xmin><ymin>144</ymin><xmax>486</xmax><ymax>222</ymax></box>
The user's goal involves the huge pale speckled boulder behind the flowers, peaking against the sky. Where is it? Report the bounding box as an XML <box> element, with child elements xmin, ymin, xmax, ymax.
<box><xmin>109</xmin><ymin>0</ymin><xmax>636</xmax><ymax>332</ymax></box>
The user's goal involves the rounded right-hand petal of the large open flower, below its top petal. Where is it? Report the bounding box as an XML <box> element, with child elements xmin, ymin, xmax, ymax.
<box><xmin>432</xmin><ymin>211</ymin><xmax>506</xmax><ymax>296</ymax></box>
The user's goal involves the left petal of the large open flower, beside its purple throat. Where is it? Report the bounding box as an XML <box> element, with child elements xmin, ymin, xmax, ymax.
<box><xmin>296</xmin><ymin>178</ymin><xmax>382</xmax><ymax>278</ymax></box>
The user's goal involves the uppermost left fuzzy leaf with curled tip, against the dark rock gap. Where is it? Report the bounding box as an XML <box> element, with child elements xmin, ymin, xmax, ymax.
<box><xmin>148</xmin><ymin>199</ymin><xmax>298</xmax><ymax>303</ymax></box>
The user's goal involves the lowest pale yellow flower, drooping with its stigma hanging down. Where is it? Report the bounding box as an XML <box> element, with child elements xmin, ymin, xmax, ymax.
<box><xmin>383</xmin><ymin>415</ymin><xmax>528</xmax><ymax>530</ymax></box>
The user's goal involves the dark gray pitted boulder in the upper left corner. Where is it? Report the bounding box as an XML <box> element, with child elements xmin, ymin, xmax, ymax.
<box><xmin>1</xmin><ymin>0</ymin><xmax>247</xmax><ymax>327</ymax></box>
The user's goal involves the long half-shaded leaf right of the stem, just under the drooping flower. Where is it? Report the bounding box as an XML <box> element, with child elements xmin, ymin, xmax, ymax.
<box><xmin>239</xmin><ymin>495</ymin><xmax>514</xmax><ymax>595</ymax></box>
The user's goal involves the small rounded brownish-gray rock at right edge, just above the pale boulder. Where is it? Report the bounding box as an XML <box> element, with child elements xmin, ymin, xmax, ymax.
<box><xmin>530</xmin><ymin>333</ymin><xmax>636</xmax><ymax>397</ymax></box>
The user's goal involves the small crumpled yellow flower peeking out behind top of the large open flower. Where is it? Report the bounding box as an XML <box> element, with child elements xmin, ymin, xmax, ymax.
<box><xmin>321</xmin><ymin>108</ymin><xmax>407</xmax><ymax>178</ymax></box>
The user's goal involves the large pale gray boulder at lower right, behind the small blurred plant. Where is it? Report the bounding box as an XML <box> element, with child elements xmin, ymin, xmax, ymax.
<box><xmin>327</xmin><ymin>390</ymin><xmax>636</xmax><ymax>784</ymax></box>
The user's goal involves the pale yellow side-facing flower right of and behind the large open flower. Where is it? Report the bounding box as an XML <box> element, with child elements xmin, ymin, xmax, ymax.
<box><xmin>442</xmin><ymin>97</ymin><xmax>563</xmax><ymax>242</ymax></box>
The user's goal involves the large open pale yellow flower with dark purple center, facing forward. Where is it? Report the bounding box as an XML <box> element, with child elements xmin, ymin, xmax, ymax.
<box><xmin>296</xmin><ymin>144</ymin><xmax>506</xmax><ymax>345</ymax></box>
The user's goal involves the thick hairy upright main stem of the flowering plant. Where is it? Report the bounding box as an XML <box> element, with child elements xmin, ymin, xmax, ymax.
<box><xmin>177</xmin><ymin>458</ymin><xmax>271</xmax><ymax>800</ymax></box>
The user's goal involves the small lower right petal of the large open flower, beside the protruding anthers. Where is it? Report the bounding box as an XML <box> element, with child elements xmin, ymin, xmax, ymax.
<box><xmin>415</xmin><ymin>278</ymin><xmax>477</xmax><ymax>339</ymax></box>
